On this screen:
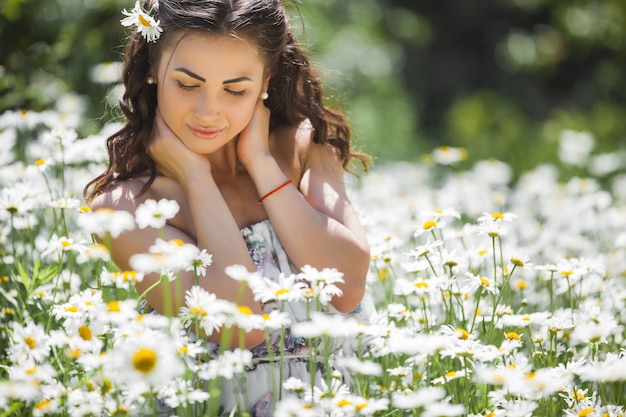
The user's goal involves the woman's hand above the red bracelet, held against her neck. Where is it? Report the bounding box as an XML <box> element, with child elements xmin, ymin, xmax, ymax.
<box><xmin>237</xmin><ymin>98</ymin><xmax>270</xmax><ymax>166</ymax></box>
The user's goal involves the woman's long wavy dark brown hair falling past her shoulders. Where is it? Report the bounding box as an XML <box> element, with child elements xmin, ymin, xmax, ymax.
<box><xmin>84</xmin><ymin>0</ymin><xmax>368</xmax><ymax>200</ymax></box>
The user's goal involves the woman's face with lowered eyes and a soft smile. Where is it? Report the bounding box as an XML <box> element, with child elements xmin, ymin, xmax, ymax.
<box><xmin>156</xmin><ymin>34</ymin><xmax>267</xmax><ymax>154</ymax></box>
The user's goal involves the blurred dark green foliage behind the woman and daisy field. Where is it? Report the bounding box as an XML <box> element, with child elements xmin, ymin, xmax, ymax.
<box><xmin>0</xmin><ymin>0</ymin><xmax>626</xmax><ymax>174</ymax></box>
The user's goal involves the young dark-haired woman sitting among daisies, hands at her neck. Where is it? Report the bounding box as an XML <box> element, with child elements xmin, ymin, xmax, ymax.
<box><xmin>85</xmin><ymin>0</ymin><xmax>370</xmax><ymax>414</ymax></box>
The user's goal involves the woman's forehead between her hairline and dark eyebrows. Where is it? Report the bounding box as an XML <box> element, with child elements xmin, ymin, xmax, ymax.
<box><xmin>159</xmin><ymin>32</ymin><xmax>264</xmax><ymax>75</ymax></box>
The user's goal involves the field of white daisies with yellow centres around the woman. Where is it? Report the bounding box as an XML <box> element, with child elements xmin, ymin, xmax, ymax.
<box><xmin>0</xmin><ymin>105</ymin><xmax>626</xmax><ymax>417</ymax></box>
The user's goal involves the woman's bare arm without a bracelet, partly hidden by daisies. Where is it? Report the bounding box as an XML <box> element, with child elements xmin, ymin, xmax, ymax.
<box><xmin>92</xmin><ymin>121</ymin><xmax>265</xmax><ymax>347</ymax></box>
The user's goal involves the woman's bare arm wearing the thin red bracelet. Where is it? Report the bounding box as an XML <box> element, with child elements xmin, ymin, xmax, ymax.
<box><xmin>240</xmin><ymin>105</ymin><xmax>370</xmax><ymax>312</ymax></box>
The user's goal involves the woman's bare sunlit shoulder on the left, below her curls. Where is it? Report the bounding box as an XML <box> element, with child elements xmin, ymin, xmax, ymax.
<box><xmin>90</xmin><ymin>177</ymin><xmax>151</xmax><ymax>213</ymax></box>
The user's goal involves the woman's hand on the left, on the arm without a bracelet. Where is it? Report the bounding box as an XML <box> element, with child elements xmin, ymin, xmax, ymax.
<box><xmin>147</xmin><ymin>108</ymin><xmax>210</xmax><ymax>184</ymax></box>
